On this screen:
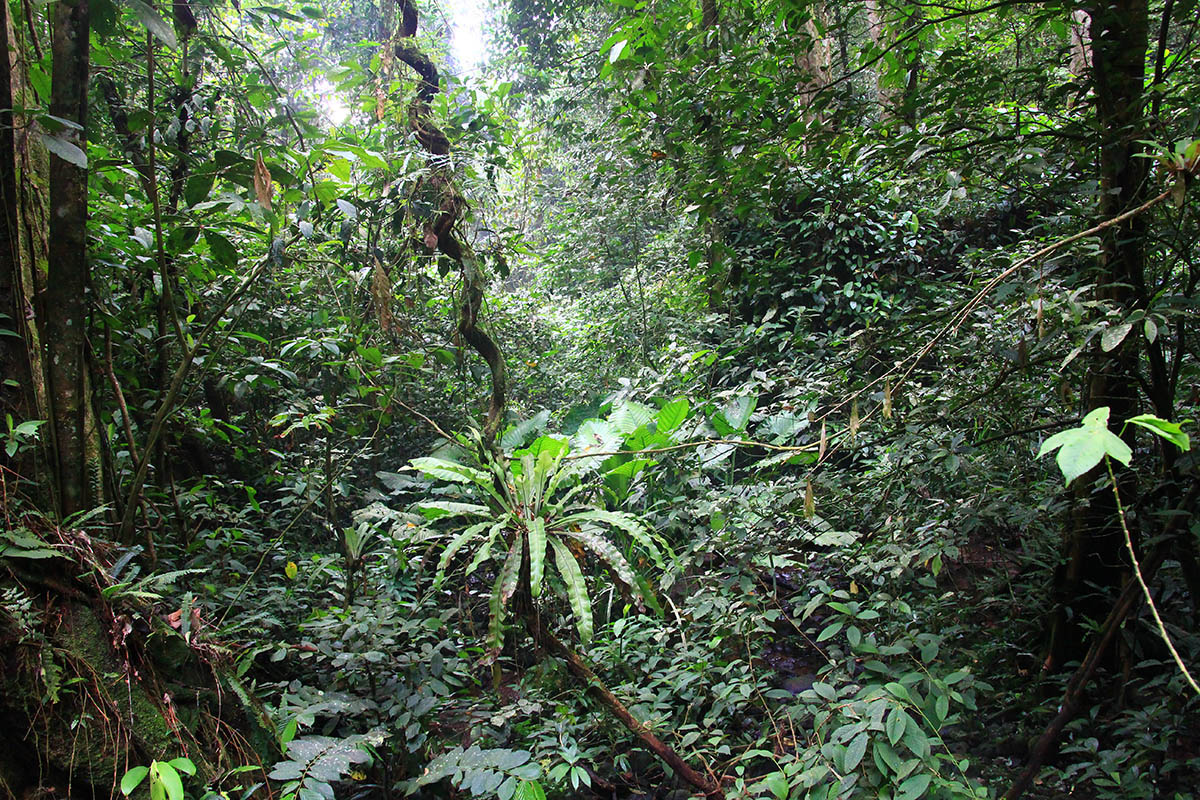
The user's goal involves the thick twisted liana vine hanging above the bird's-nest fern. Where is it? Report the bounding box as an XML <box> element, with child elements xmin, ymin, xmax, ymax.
<box><xmin>395</xmin><ymin>0</ymin><xmax>506</xmax><ymax>452</ymax></box>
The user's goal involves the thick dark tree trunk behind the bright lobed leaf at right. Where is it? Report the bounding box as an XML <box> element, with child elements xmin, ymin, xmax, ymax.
<box><xmin>1046</xmin><ymin>0</ymin><xmax>1148</xmax><ymax>669</ymax></box>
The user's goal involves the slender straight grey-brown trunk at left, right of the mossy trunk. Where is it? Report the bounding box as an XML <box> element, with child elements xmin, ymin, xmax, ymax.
<box><xmin>44</xmin><ymin>0</ymin><xmax>96</xmax><ymax>516</ymax></box>
